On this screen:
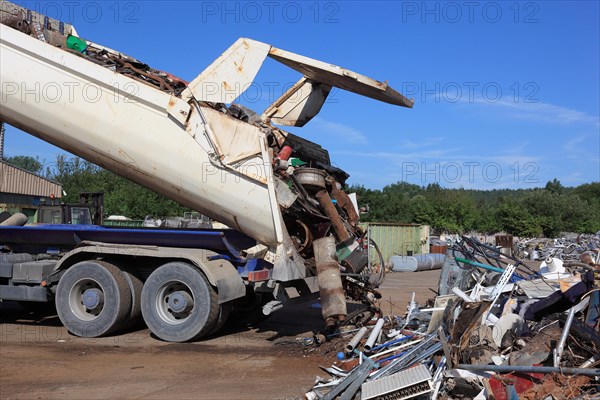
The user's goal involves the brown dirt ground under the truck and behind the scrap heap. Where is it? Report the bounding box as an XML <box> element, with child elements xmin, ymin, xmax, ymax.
<box><xmin>0</xmin><ymin>270</ymin><xmax>440</xmax><ymax>400</ymax></box>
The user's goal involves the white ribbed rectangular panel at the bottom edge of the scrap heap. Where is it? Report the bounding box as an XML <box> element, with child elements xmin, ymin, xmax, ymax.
<box><xmin>361</xmin><ymin>364</ymin><xmax>433</xmax><ymax>400</ymax></box>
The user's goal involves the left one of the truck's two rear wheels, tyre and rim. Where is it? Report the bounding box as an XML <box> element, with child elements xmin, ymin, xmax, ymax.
<box><xmin>56</xmin><ymin>261</ymin><xmax>131</xmax><ymax>337</ymax></box>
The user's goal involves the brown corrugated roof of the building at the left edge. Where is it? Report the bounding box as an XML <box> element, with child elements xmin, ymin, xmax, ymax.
<box><xmin>0</xmin><ymin>161</ymin><xmax>62</xmax><ymax>198</ymax></box>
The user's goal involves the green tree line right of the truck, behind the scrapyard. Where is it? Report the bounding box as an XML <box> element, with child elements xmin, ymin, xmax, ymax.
<box><xmin>349</xmin><ymin>179</ymin><xmax>600</xmax><ymax>237</ymax></box>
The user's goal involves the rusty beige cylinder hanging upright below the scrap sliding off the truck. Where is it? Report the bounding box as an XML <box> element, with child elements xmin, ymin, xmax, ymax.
<box><xmin>313</xmin><ymin>236</ymin><xmax>347</xmax><ymax>325</ymax></box>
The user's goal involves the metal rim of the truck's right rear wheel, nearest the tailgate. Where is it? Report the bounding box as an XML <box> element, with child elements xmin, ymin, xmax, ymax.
<box><xmin>155</xmin><ymin>281</ymin><xmax>195</xmax><ymax>325</ymax></box>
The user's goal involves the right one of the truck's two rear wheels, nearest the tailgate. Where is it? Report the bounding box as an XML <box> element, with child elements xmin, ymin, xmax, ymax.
<box><xmin>142</xmin><ymin>262</ymin><xmax>220</xmax><ymax>342</ymax></box>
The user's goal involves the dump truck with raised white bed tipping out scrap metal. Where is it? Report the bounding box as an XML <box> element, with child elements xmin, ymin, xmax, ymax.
<box><xmin>0</xmin><ymin>1</ymin><xmax>413</xmax><ymax>342</ymax></box>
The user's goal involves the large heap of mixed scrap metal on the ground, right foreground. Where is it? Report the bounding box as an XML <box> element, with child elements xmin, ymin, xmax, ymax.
<box><xmin>306</xmin><ymin>236</ymin><xmax>600</xmax><ymax>400</ymax></box>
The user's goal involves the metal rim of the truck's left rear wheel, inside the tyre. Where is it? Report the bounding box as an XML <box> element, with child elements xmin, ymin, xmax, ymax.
<box><xmin>69</xmin><ymin>279</ymin><xmax>104</xmax><ymax>321</ymax></box>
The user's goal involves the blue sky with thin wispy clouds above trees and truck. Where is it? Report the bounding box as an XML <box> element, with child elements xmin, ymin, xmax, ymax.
<box><xmin>5</xmin><ymin>1</ymin><xmax>600</xmax><ymax>189</ymax></box>
